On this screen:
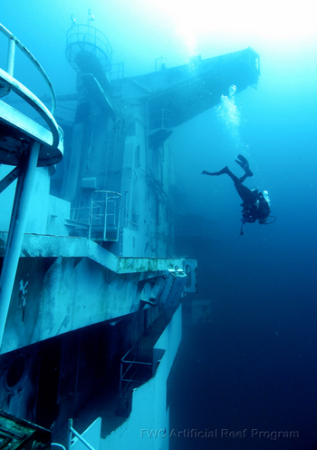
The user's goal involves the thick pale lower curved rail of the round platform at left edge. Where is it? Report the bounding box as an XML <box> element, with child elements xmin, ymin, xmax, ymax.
<box><xmin>0</xmin><ymin>69</ymin><xmax>60</xmax><ymax>148</ymax></box>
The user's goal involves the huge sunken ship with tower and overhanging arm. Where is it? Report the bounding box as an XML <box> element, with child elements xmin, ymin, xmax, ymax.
<box><xmin>0</xmin><ymin>18</ymin><xmax>259</xmax><ymax>450</ymax></box>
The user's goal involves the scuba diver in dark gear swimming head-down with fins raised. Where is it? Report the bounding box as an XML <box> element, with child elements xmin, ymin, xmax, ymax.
<box><xmin>202</xmin><ymin>155</ymin><xmax>276</xmax><ymax>236</ymax></box>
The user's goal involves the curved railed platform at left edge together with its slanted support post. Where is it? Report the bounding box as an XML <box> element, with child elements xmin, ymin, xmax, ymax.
<box><xmin>0</xmin><ymin>24</ymin><xmax>63</xmax><ymax>347</ymax></box>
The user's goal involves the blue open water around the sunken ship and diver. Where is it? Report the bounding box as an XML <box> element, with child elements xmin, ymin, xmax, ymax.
<box><xmin>1</xmin><ymin>0</ymin><xmax>317</xmax><ymax>450</ymax></box>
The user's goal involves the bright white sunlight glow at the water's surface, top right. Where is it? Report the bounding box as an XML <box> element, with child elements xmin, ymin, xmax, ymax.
<box><xmin>148</xmin><ymin>0</ymin><xmax>316</xmax><ymax>54</ymax></box>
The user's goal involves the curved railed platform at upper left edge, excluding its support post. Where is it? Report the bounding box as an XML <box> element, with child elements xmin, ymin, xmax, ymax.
<box><xmin>0</xmin><ymin>24</ymin><xmax>63</xmax><ymax>167</ymax></box>
